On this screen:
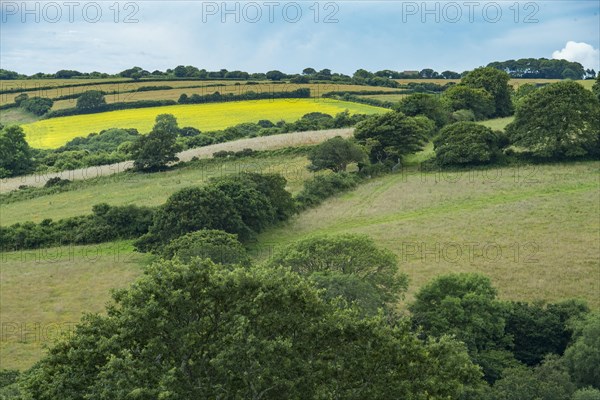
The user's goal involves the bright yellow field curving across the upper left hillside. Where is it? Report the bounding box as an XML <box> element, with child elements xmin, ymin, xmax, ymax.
<box><xmin>23</xmin><ymin>99</ymin><xmax>387</xmax><ymax>148</ymax></box>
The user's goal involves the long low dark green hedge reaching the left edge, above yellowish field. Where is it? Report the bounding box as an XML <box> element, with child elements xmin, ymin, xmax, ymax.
<box><xmin>0</xmin><ymin>204</ymin><xmax>153</xmax><ymax>251</ymax></box>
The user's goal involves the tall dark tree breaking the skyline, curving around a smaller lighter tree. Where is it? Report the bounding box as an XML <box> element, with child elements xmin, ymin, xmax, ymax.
<box><xmin>461</xmin><ymin>67</ymin><xmax>514</xmax><ymax>117</ymax></box>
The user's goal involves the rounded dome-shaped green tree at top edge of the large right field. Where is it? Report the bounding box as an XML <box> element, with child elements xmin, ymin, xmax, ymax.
<box><xmin>433</xmin><ymin>122</ymin><xmax>500</xmax><ymax>165</ymax></box>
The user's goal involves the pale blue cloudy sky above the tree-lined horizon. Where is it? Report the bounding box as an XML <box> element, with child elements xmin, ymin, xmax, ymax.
<box><xmin>0</xmin><ymin>0</ymin><xmax>600</xmax><ymax>74</ymax></box>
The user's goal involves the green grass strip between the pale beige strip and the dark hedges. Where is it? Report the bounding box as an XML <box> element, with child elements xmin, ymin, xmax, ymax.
<box><xmin>0</xmin><ymin>155</ymin><xmax>312</xmax><ymax>226</ymax></box>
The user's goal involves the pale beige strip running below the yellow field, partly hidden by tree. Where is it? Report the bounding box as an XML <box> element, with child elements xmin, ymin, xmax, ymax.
<box><xmin>0</xmin><ymin>128</ymin><xmax>354</xmax><ymax>193</ymax></box>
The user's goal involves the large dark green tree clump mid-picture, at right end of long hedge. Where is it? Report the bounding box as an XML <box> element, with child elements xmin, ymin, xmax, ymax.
<box><xmin>135</xmin><ymin>173</ymin><xmax>295</xmax><ymax>251</ymax></box>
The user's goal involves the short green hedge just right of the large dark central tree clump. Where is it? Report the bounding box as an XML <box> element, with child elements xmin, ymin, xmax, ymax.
<box><xmin>296</xmin><ymin>172</ymin><xmax>362</xmax><ymax>209</ymax></box>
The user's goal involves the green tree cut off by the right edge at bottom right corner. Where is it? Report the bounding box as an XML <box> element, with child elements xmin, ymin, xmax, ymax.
<box><xmin>564</xmin><ymin>312</ymin><xmax>600</xmax><ymax>389</ymax></box>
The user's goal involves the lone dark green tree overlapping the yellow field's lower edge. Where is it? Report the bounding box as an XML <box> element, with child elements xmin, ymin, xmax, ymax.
<box><xmin>131</xmin><ymin>114</ymin><xmax>180</xmax><ymax>171</ymax></box>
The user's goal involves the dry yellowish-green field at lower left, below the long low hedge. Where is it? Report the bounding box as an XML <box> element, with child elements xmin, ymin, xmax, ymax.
<box><xmin>0</xmin><ymin>242</ymin><xmax>149</xmax><ymax>369</ymax></box>
